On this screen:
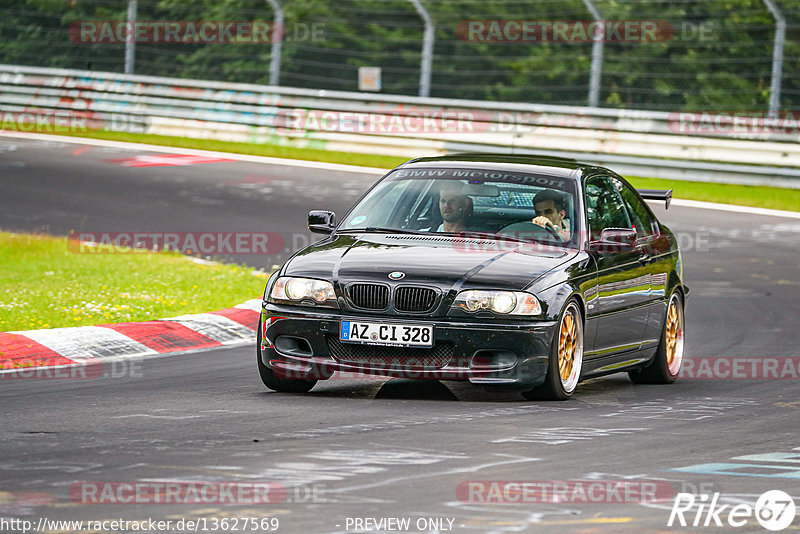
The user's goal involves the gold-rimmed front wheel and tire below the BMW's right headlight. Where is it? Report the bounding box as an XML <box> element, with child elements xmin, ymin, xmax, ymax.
<box><xmin>522</xmin><ymin>299</ymin><xmax>583</xmax><ymax>400</ymax></box>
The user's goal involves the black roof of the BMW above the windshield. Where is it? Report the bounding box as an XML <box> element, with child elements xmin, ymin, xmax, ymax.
<box><xmin>399</xmin><ymin>152</ymin><xmax>594</xmax><ymax>179</ymax></box>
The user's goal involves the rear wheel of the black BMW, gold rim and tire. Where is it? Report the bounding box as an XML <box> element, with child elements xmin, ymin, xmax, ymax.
<box><xmin>628</xmin><ymin>290</ymin><xmax>684</xmax><ymax>384</ymax></box>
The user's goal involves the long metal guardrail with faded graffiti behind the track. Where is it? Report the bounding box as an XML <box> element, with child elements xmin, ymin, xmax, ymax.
<box><xmin>0</xmin><ymin>65</ymin><xmax>800</xmax><ymax>188</ymax></box>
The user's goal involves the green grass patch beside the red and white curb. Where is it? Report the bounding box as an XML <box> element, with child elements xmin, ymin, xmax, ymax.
<box><xmin>0</xmin><ymin>232</ymin><xmax>266</xmax><ymax>332</ymax></box>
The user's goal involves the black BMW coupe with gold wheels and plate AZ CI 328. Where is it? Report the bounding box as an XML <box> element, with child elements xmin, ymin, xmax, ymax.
<box><xmin>256</xmin><ymin>154</ymin><xmax>688</xmax><ymax>399</ymax></box>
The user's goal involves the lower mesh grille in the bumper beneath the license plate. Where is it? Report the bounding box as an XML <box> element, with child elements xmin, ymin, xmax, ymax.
<box><xmin>327</xmin><ymin>336</ymin><xmax>454</xmax><ymax>371</ymax></box>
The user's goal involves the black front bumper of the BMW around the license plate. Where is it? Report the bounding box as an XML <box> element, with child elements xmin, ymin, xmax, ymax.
<box><xmin>260</xmin><ymin>304</ymin><xmax>556</xmax><ymax>388</ymax></box>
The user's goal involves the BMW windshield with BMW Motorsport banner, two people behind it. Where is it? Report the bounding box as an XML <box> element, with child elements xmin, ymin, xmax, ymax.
<box><xmin>337</xmin><ymin>168</ymin><xmax>579</xmax><ymax>248</ymax></box>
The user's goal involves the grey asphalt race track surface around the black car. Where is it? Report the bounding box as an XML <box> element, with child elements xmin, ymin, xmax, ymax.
<box><xmin>0</xmin><ymin>138</ymin><xmax>800</xmax><ymax>533</ymax></box>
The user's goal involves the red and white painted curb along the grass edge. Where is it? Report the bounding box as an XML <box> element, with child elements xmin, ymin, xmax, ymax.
<box><xmin>0</xmin><ymin>299</ymin><xmax>261</xmax><ymax>374</ymax></box>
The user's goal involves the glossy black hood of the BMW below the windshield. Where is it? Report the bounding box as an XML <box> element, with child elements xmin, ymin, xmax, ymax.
<box><xmin>284</xmin><ymin>234</ymin><xmax>577</xmax><ymax>292</ymax></box>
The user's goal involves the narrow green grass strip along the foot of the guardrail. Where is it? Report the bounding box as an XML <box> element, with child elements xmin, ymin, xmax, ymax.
<box><xmin>36</xmin><ymin>130</ymin><xmax>800</xmax><ymax>211</ymax></box>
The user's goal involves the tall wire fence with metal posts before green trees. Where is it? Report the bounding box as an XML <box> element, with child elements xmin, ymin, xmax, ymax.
<box><xmin>0</xmin><ymin>0</ymin><xmax>800</xmax><ymax>113</ymax></box>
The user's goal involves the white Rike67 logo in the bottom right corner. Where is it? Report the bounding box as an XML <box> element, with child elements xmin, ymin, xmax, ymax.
<box><xmin>667</xmin><ymin>490</ymin><xmax>796</xmax><ymax>532</ymax></box>
